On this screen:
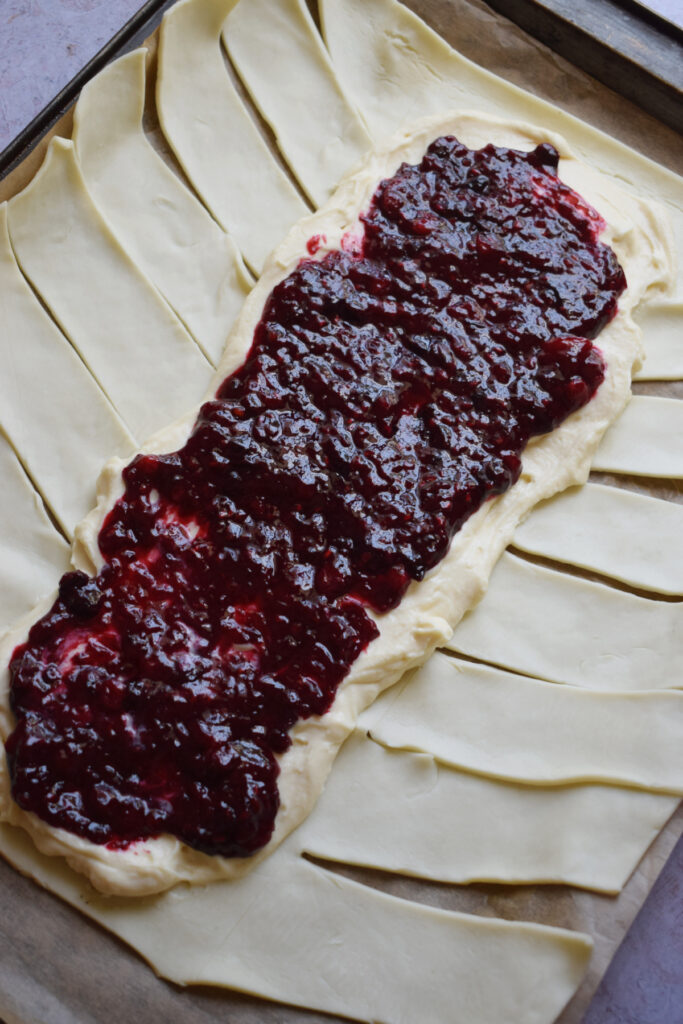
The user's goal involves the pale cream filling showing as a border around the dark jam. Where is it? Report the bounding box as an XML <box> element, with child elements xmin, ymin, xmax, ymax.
<box><xmin>0</xmin><ymin>112</ymin><xmax>671</xmax><ymax>894</ymax></box>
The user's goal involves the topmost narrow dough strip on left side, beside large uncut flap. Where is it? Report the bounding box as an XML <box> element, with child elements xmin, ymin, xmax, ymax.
<box><xmin>223</xmin><ymin>0</ymin><xmax>371</xmax><ymax>206</ymax></box>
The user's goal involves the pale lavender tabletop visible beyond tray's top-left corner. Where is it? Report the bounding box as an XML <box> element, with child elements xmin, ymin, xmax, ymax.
<box><xmin>0</xmin><ymin>0</ymin><xmax>142</xmax><ymax>153</ymax></box>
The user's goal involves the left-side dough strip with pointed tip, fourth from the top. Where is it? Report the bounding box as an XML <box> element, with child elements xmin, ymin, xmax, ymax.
<box><xmin>8</xmin><ymin>138</ymin><xmax>211</xmax><ymax>440</ymax></box>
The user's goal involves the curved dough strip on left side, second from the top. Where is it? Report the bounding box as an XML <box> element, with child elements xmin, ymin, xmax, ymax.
<box><xmin>157</xmin><ymin>0</ymin><xmax>308</xmax><ymax>271</ymax></box>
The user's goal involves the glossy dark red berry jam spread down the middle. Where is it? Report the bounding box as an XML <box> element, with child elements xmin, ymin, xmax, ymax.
<box><xmin>7</xmin><ymin>138</ymin><xmax>625</xmax><ymax>856</ymax></box>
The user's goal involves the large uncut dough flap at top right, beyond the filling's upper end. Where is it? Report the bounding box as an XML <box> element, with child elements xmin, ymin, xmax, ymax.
<box><xmin>318</xmin><ymin>0</ymin><xmax>683</xmax><ymax>379</ymax></box>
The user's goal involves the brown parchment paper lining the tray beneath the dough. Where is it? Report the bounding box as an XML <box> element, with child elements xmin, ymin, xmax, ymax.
<box><xmin>0</xmin><ymin>0</ymin><xmax>683</xmax><ymax>1024</ymax></box>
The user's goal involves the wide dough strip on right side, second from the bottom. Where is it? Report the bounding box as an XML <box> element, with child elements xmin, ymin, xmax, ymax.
<box><xmin>298</xmin><ymin>733</ymin><xmax>678</xmax><ymax>893</ymax></box>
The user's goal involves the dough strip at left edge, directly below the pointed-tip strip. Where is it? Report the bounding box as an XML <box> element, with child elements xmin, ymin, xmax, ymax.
<box><xmin>0</xmin><ymin>204</ymin><xmax>133</xmax><ymax>536</ymax></box>
